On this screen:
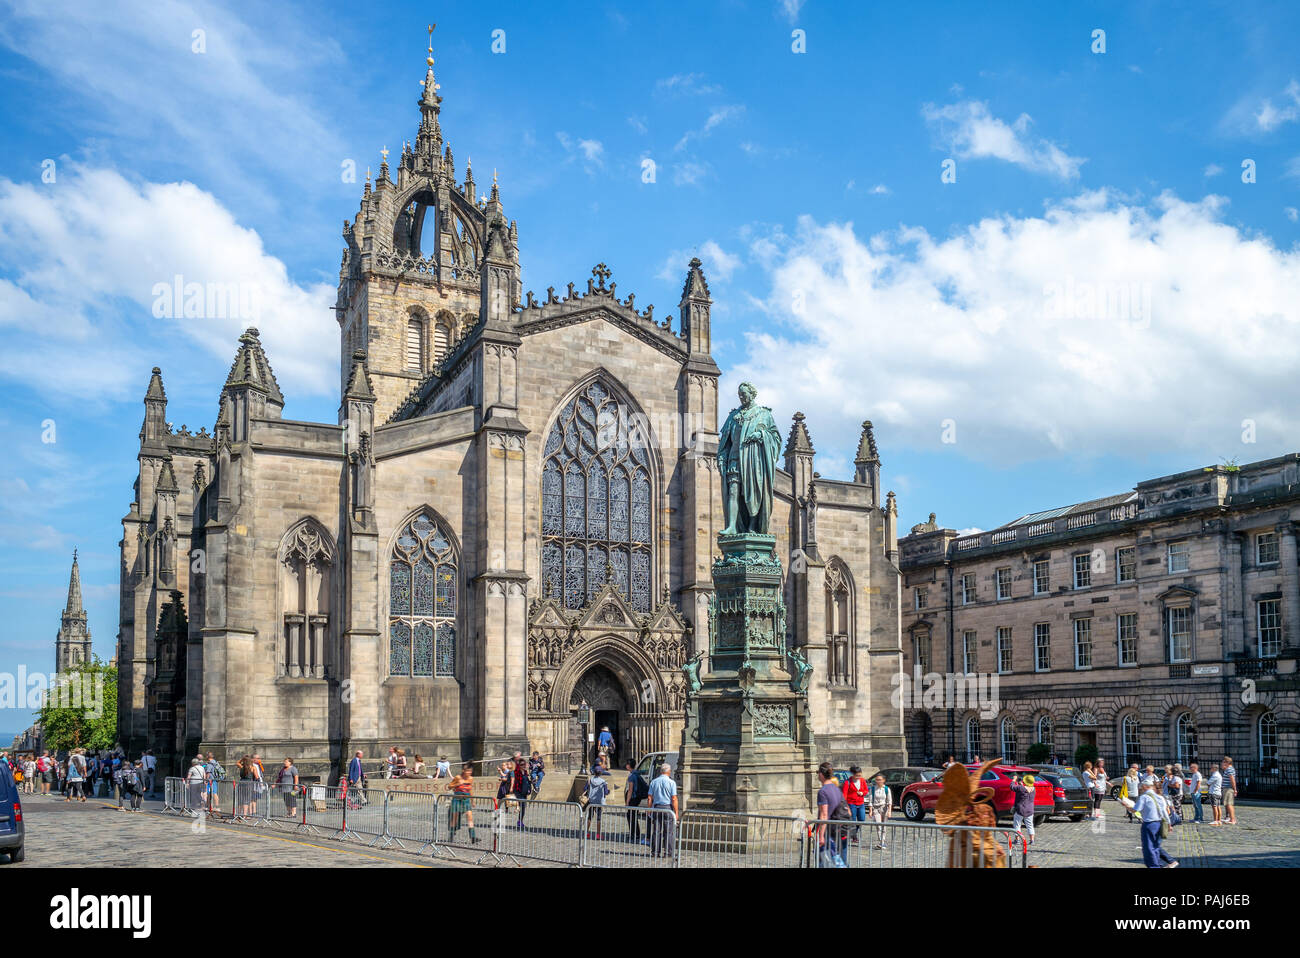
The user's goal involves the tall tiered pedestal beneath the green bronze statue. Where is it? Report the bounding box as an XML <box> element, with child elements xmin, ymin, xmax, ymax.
<box><xmin>677</xmin><ymin>533</ymin><xmax>816</xmax><ymax>815</ymax></box>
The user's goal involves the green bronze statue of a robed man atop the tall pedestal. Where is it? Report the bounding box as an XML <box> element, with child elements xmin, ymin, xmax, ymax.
<box><xmin>718</xmin><ymin>382</ymin><xmax>781</xmax><ymax>536</ymax></box>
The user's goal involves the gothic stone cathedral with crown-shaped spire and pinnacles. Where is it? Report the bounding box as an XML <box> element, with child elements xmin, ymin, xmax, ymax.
<box><xmin>118</xmin><ymin>41</ymin><xmax>904</xmax><ymax>775</ymax></box>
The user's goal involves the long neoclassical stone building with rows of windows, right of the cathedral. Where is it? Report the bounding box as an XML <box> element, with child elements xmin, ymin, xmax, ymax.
<box><xmin>901</xmin><ymin>454</ymin><xmax>1300</xmax><ymax>789</ymax></box>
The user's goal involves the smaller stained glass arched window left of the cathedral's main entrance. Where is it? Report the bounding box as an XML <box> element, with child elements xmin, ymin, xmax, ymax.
<box><xmin>389</xmin><ymin>515</ymin><xmax>459</xmax><ymax>676</ymax></box>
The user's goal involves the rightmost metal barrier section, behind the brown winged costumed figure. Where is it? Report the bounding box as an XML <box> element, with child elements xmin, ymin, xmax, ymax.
<box><xmin>805</xmin><ymin>819</ymin><xmax>1028</xmax><ymax>868</ymax></box>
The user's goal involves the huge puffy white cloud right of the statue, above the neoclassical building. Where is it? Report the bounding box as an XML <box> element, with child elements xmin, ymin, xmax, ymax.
<box><xmin>728</xmin><ymin>191</ymin><xmax>1300</xmax><ymax>461</ymax></box>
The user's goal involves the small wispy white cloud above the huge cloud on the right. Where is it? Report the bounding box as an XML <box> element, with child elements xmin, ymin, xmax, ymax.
<box><xmin>920</xmin><ymin>100</ymin><xmax>1086</xmax><ymax>179</ymax></box>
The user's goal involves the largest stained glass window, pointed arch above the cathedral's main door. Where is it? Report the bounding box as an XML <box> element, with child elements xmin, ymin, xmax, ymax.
<box><xmin>542</xmin><ymin>380</ymin><xmax>654</xmax><ymax>612</ymax></box>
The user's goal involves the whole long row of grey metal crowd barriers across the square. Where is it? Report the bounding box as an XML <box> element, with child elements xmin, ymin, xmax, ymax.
<box><xmin>149</xmin><ymin>777</ymin><xmax>1028</xmax><ymax>868</ymax></box>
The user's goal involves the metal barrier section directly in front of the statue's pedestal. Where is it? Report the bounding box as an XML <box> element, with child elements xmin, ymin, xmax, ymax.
<box><xmin>677</xmin><ymin>811</ymin><xmax>807</xmax><ymax>868</ymax></box>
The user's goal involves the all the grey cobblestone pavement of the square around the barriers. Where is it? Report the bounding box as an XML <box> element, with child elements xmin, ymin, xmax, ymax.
<box><xmin>4</xmin><ymin>796</ymin><xmax>1300</xmax><ymax>868</ymax></box>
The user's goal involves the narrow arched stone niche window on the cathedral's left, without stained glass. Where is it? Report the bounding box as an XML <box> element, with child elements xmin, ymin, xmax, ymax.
<box><xmin>277</xmin><ymin>519</ymin><xmax>334</xmax><ymax>679</ymax></box>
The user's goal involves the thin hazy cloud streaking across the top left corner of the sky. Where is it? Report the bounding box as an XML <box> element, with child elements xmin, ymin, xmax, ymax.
<box><xmin>0</xmin><ymin>0</ymin><xmax>345</xmax><ymax>207</ymax></box>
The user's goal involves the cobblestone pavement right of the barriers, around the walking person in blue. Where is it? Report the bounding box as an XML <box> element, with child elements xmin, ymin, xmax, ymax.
<box><xmin>1013</xmin><ymin>801</ymin><xmax>1300</xmax><ymax>868</ymax></box>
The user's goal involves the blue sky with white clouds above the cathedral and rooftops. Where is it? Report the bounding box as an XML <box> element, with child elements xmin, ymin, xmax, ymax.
<box><xmin>0</xmin><ymin>0</ymin><xmax>1300</xmax><ymax>729</ymax></box>
